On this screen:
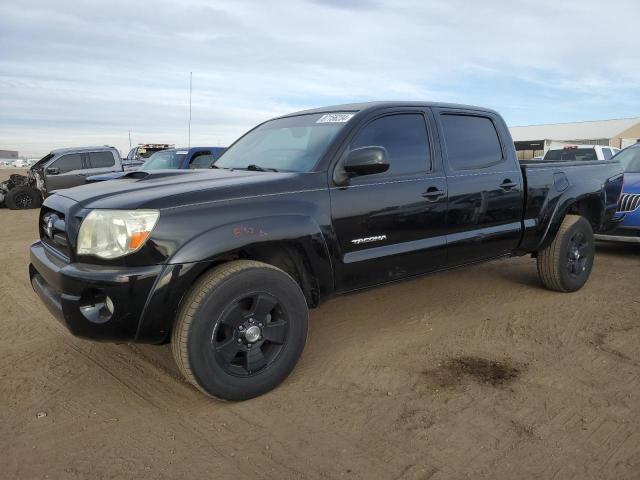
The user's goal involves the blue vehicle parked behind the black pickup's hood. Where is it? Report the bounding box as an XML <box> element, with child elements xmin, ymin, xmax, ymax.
<box><xmin>87</xmin><ymin>147</ymin><xmax>225</xmax><ymax>183</ymax></box>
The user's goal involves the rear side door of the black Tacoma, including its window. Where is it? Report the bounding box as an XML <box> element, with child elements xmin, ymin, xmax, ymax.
<box><xmin>434</xmin><ymin>108</ymin><xmax>524</xmax><ymax>266</ymax></box>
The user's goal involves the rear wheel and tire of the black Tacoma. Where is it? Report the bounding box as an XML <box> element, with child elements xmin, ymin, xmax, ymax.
<box><xmin>538</xmin><ymin>215</ymin><xmax>595</xmax><ymax>292</ymax></box>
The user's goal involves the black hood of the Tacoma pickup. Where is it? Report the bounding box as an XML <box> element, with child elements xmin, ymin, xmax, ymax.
<box><xmin>56</xmin><ymin>169</ymin><xmax>314</xmax><ymax>209</ymax></box>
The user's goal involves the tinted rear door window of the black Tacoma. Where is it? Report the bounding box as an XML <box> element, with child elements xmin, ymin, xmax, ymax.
<box><xmin>441</xmin><ymin>115</ymin><xmax>503</xmax><ymax>170</ymax></box>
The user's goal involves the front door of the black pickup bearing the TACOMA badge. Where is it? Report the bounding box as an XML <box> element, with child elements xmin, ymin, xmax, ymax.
<box><xmin>331</xmin><ymin>109</ymin><xmax>447</xmax><ymax>291</ymax></box>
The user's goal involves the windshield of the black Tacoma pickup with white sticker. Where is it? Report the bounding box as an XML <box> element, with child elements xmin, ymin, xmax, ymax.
<box><xmin>215</xmin><ymin>113</ymin><xmax>354</xmax><ymax>172</ymax></box>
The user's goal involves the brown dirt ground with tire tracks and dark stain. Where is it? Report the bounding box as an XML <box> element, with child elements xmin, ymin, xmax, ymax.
<box><xmin>0</xmin><ymin>170</ymin><xmax>640</xmax><ymax>480</ymax></box>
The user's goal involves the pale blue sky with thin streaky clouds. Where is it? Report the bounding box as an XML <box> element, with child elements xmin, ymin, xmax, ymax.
<box><xmin>0</xmin><ymin>0</ymin><xmax>640</xmax><ymax>158</ymax></box>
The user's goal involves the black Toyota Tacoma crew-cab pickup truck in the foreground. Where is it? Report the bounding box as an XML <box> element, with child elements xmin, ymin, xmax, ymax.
<box><xmin>29</xmin><ymin>102</ymin><xmax>623</xmax><ymax>400</ymax></box>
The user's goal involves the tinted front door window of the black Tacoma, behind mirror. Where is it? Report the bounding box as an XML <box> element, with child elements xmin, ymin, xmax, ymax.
<box><xmin>351</xmin><ymin>113</ymin><xmax>431</xmax><ymax>175</ymax></box>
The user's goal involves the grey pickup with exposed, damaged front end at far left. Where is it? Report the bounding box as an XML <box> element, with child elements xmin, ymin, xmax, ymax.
<box><xmin>0</xmin><ymin>146</ymin><xmax>123</xmax><ymax>210</ymax></box>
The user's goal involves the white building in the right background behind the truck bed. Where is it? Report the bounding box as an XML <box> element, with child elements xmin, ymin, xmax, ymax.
<box><xmin>509</xmin><ymin>118</ymin><xmax>640</xmax><ymax>160</ymax></box>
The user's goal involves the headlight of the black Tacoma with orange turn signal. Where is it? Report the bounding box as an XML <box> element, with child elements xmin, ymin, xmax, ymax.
<box><xmin>77</xmin><ymin>210</ymin><xmax>160</xmax><ymax>258</ymax></box>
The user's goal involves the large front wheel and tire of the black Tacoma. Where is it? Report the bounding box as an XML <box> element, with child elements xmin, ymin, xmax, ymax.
<box><xmin>171</xmin><ymin>260</ymin><xmax>309</xmax><ymax>400</ymax></box>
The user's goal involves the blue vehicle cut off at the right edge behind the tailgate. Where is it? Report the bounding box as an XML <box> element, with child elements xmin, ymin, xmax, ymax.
<box><xmin>596</xmin><ymin>143</ymin><xmax>640</xmax><ymax>243</ymax></box>
